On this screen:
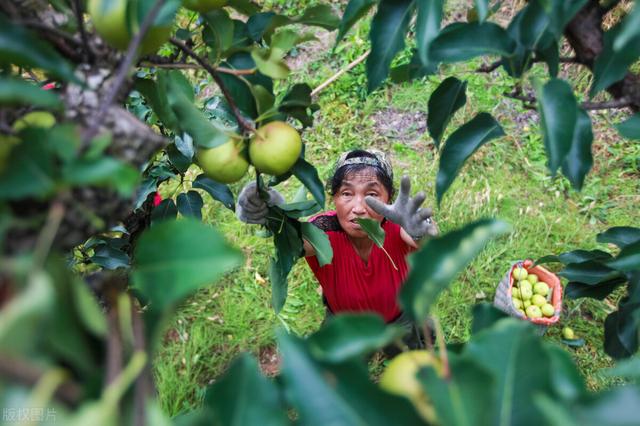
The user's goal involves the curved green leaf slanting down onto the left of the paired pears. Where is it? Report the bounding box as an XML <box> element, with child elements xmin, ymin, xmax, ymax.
<box><xmin>167</xmin><ymin>70</ymin><xmax>229</xmax><ymax>148</ymax></box>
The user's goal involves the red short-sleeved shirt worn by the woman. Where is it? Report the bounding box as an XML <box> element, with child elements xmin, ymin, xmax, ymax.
<box><xmin>305</xmin><ymin>211</ymin><xmax>413</xmax><ymax>322</ymax></box>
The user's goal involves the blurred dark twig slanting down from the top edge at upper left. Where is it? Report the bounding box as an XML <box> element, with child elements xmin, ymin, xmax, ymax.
<box><xmin>83</xmin><ymin>0</ymin><xmax>165</xmax><ymax>146</ymax></box>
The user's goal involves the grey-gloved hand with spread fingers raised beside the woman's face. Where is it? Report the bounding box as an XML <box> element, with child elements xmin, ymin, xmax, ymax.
<box><xmin>365</xmin><ymin>176</ymin><xmax>438</xmax><ymax>240</ymax></box>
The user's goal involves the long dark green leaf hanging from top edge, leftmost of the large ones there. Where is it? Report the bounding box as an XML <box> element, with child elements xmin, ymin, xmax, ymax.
<box><xmin>366</xmin><ymin>0</ymin><xmax>414</xmax><ymax>92</ymax></box>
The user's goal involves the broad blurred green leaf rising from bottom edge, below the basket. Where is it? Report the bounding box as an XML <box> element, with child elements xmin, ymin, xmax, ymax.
<box><xmin>462</xmin><ymin>319</ymin><xmax>552</xmax><ymax>425</ymax></box>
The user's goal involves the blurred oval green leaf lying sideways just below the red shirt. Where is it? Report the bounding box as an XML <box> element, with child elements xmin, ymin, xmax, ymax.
<box><xmin>308</xmin><ymin>314</ymin><xmax>405</xmax><ymax>363</ymax></box>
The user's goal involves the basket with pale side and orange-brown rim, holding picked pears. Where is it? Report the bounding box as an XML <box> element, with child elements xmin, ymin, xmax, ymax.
<box><xmin>493</xmin><ymin>259</ymin><xmax>562</xmax><ymax>329</ymax></box>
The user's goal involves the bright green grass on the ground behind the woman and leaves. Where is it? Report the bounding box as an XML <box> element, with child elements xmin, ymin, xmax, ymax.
<box><xmin>155</xmin><ymin>2</ymin><xmax>640</xmax><ymax>415</ymax></box>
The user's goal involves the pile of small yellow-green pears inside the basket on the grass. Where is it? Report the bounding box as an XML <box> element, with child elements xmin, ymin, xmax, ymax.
<box><xmin>511</xmin><ymin>266</ymin><xmax>555</xmax><ymax>318</ymax></box>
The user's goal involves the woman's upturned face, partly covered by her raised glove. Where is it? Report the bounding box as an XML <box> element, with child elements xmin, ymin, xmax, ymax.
<box><xmin>333</xmin><ymin>168</ymin><xmax>389</xmax><ymax>238</ymax></box>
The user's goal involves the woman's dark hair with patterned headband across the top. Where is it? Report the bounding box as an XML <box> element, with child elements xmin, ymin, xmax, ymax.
<box><xmin>327</xmin><ymin>149</ymin><xmax>394</xmax><ymax>198</ymax></box>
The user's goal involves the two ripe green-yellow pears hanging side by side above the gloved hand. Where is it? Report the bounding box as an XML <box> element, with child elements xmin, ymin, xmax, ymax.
<box><xmin>196</xmin><ymin>121</ymin><xmax>302</xmax><ymax>183</ymax></box>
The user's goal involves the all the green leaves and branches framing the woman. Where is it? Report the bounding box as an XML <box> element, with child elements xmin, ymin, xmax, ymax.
<box><xmin>0</xmin><ymin>0</ymin><xmax>640</xmax><ymax>425</ymax></box>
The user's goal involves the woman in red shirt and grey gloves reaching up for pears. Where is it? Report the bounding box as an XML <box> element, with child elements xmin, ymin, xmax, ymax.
<box><xmin>236</xmin><ymin>150</ymin><xmax>438</xmax><ymax>346</ymax></box>
